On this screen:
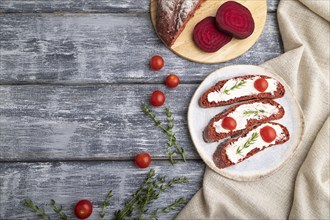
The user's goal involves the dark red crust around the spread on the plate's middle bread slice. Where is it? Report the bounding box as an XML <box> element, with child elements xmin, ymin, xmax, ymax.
<box><xmin>203</xmin><ymin>99</ymin><xmax>285</xmax><ymax>143</ymax></box>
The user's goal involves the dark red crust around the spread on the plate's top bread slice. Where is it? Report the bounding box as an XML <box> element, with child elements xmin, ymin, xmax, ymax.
<box><xmin>199</xmin><ymin>75</ymin><xmax>285</xmax><ymax>108</ymax></box>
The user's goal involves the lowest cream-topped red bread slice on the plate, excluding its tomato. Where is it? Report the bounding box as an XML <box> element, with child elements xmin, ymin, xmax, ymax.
<box><xmin>213</xmin><ymin>122</ymin><xmax>290</xmax><ymax>169</ymax></box>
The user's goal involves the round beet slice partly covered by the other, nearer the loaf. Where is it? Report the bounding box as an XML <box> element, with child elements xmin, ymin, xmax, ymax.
<box><xmin>193</xmin><ymin>17</ymin><xmax>232</xmax><ymax>53</ymax></box>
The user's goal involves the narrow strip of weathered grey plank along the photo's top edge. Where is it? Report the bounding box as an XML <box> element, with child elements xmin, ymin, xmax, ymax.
<box><xmin>0</xmin><ymin>0</ymin><xmax>279</xmax><ymax>13</ymax></box>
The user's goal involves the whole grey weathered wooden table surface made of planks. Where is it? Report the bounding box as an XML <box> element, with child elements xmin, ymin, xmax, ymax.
<box><xmin>0</xmin><ymin>0</ymin><xmax>283</xmax><ymax>219</ymax></box>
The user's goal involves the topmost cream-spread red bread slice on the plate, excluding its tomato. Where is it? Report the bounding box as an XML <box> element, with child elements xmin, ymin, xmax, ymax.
<box><xmin>199</xmin><ymin>75</ymin><xmax>285</xmax><ymax>108</ymax></box>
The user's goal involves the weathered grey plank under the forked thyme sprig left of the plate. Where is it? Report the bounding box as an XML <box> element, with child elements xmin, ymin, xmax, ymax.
<box><xmin>0</xmin><ymin>84</ymin><xmax>204</xmax><ymax>161</ymax></box>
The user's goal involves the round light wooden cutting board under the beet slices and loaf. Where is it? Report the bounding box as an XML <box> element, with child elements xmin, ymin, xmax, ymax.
<box><xmin>150</xmin><ymin>0</ymin><xmax>267</xmax><ymax>64</ymax></box>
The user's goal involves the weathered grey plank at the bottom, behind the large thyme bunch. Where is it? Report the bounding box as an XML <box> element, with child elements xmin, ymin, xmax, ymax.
<box><xmin>0</xmin><ymin>161</ymin><xmax>204</xmax><ymax>220</ymax></box>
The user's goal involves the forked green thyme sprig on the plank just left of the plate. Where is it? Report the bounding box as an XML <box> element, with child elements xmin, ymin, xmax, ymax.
<box><xmin>141</xmin><ymin>102</ymin><xmax>186</xmax><ymax>165</ymax></box>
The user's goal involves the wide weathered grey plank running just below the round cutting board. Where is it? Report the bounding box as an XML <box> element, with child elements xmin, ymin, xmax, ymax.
<box><xmin>0</xmin><ymin>13</ymin><xmax>283</xmax><ymax>84</ymax></box>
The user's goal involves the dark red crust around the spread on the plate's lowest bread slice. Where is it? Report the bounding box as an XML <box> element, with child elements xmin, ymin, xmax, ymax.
<box><xmin>213</xmin><ymin>122</ymin><xmax>290</xmax><ymax>169</ymax></box>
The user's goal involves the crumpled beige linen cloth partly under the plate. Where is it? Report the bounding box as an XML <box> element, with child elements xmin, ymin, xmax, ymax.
<box><xmin>177</xmin><ymin>0</ymin><xmax>330</xmax><ymax>219</ymax></box>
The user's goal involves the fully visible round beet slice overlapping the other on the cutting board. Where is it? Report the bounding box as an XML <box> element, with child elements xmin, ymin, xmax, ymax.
<box><xmin>216</xmin><ymin>1</ymin><xmax>254</xmax><ymax>39</ymax></box>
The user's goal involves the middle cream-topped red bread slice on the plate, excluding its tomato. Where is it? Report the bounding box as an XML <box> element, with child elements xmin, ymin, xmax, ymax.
<box><xmin>203</xmin><ymin>99</ymin><xmax>285</xmax><ymax>143</ymax></box>
